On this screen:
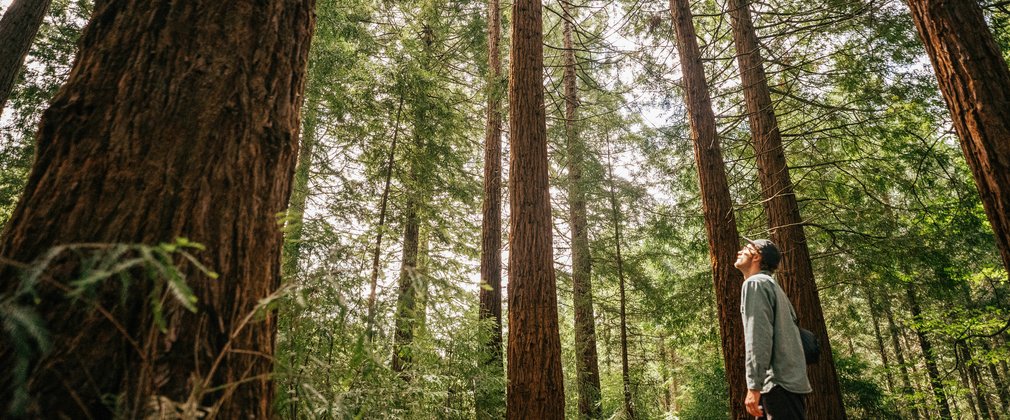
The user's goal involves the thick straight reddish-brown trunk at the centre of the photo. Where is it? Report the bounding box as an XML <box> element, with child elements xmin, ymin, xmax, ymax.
<box><xmin>506</xmin><ymin>0</ymin><xmax>565</xmax><ymax>420</ymax></box>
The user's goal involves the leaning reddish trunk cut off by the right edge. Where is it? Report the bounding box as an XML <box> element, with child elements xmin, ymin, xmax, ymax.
<box><xmin>907</xmin><ymin>0</ymin><xmax>1010</xmax><ymax>270</ymax></box>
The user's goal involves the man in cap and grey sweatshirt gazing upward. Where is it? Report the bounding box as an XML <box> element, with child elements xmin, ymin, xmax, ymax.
<box><xmin>733</xmin><ymin>238</ymin><xmax>813</xmax><ymax>420</ymax></box>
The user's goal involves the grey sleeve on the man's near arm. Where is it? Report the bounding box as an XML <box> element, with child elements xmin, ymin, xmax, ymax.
<box><xmin>740</xmin><ymin>280</ymin><xmax>775</xmax><ymax>390</ymax></box>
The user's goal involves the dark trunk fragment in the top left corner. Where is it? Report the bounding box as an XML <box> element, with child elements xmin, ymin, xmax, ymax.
<box><xmin>0</xmin><ymin>0</ymin><xmax>51</xmax><ymax>113</ymax></box>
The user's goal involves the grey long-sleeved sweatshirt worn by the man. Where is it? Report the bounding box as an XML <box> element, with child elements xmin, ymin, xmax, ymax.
<box><xmin>740</xmin><ymin>272</ymin><xmax>813</xmax><ymax>394</ymax></box>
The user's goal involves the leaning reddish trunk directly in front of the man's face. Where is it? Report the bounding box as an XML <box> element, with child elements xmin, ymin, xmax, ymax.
<box><xmin>670</xmin><ymin>0</ymin><xmax>750</xmax><ymax>419</ymax></box>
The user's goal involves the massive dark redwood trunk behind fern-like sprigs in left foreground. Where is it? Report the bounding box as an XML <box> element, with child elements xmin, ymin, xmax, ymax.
<box><xmin>0</xmin><ymin>0</ymin><xmax>314</xmax><ymax>418</ymax></box>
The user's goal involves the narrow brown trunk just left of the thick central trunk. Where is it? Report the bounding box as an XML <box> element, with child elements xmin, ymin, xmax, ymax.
<box><xmin>476</xmin><ymin>0</ymin><xmax>505</xmax><ymax>413</ymax></box>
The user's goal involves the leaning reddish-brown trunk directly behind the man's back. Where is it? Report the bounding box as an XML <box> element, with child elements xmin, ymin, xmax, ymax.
<box><xmin>729</xmin><ymin>0</ymin><xmax>845</xmax><ymax>419</ymax></box>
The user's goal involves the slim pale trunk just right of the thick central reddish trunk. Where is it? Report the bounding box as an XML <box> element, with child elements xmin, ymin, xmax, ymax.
<box><xmin>562</xmin><ymin>0</ymin><xmax>603</xmax><ymax>419</ymax></box>
